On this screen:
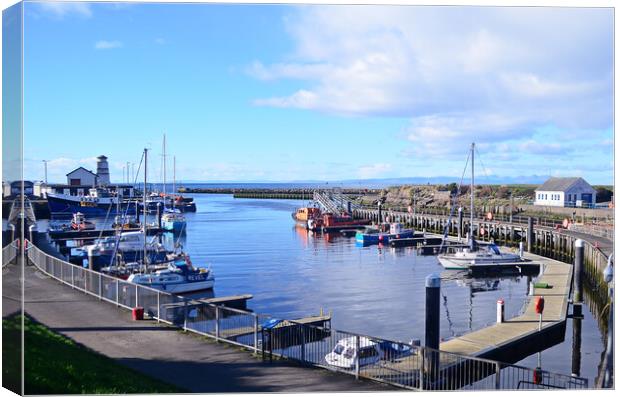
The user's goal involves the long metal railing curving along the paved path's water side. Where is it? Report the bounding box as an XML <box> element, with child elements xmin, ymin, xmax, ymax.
<box><xmin>28</xmin><ymin>241</ymin><xmax>588</xmax><ymax>390</ymax></box>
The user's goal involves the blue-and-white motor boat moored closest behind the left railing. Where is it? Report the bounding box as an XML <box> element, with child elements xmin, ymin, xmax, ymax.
<box><xmin>127</xmin><ymin>254</ymin><xmax>215</xmax><ymax>293</ymax></box>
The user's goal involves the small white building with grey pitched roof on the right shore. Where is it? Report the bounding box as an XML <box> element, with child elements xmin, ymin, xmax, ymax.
<box><xmin>534</xmin><ymin>178</ymin><xmax>596</xmax><ymax>207</ymax></box>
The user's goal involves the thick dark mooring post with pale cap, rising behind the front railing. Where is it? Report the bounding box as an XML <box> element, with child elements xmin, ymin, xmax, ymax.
<box><xmin>424</xmin><ymin>274</ymin><xmax>441</xmax><ymax>384</ymax></box>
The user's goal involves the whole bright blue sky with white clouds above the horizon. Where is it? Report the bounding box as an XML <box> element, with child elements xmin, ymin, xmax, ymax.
<box><xmin>24</xmin><ymin>2</ymin><xmax>613</xmax><ymax>183</ymax></box>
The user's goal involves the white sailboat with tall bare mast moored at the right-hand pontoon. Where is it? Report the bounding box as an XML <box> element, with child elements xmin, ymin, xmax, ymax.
<box><xmin>437</xmin><ymin>143</ymin><xmax>522</xmax><ymax>269</ymax></box>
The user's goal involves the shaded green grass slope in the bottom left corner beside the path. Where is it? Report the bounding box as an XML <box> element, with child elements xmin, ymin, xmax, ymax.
<box><xmin>2</xmin><ymin>316</ymin><xmax>186</xmax><ymax>394</ymax></box>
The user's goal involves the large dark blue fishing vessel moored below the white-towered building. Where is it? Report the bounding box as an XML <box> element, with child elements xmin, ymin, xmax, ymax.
<box><xmin>47</xmin><ymin>187</ymin><xmax>136</xmax><ymax>216</ymax></box>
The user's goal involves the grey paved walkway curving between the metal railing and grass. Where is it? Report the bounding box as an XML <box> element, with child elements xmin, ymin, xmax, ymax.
<box><xmin>2</xmin><ymin>265</ymin><xmax>399</xmax><ymax>393</ymax></box>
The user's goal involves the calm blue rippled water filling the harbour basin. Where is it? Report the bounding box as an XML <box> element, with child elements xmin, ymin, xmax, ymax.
<box><xmin>43</xmin><ymin>194</ymin><xmax>604</xmax><ymax>385</ymax></box>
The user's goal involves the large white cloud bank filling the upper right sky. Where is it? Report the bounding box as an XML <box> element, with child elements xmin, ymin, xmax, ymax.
<box><xmin>248</xmin><ymin>6</ymin><xmax>613</xmax><ymax>144</ymax></box>
